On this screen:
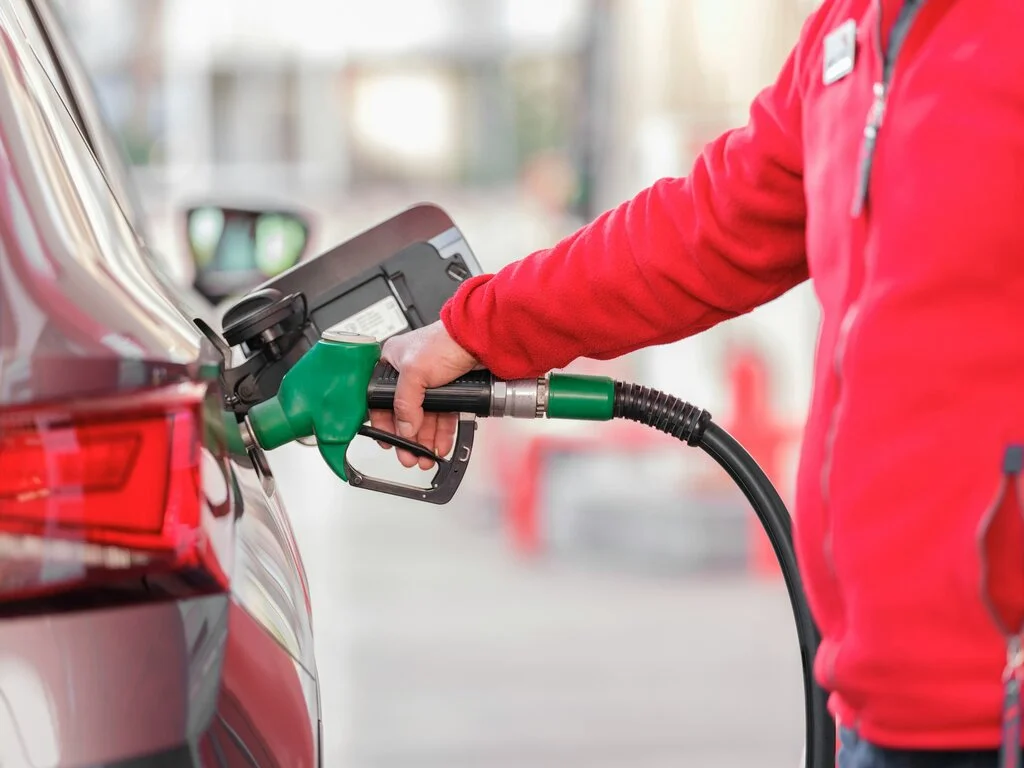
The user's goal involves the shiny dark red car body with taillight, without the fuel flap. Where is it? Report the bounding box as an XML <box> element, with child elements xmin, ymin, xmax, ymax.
<box><xmin>0</xmin><ymin>0</ymin><xmax>321</xmax><ymax>768</ymax></box>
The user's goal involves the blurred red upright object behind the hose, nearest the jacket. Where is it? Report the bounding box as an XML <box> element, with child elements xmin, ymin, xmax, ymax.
<box><xmin>723</xmin><ymin>347</ymin><xmax>799</xmax><ymax>577</ymax></box>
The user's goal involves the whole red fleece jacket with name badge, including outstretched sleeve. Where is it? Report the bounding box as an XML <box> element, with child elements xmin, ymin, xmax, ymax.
<box><xmin>442</xmin><ymin>0</ymin><xmax>1024</xmax><ymax>748</ymax></box>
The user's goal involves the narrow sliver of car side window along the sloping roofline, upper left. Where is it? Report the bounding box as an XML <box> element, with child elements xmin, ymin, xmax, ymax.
<box><xmin>8</xmin><ymin>0</ymin><xmax>145</xmax><ymax>234</ymax></box>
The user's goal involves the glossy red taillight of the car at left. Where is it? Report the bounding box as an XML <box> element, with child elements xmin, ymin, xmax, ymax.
<box><xmin>0</xmin><ymin>385</ymin><xmax>226</xmax><ymax>600</ymax></box>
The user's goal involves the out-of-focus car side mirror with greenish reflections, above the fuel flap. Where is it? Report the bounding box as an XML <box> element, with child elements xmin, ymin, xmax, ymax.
<box><xmin>185</xmin><ymin>205</ymin><xmax>310</xmax><ymax>304</ymax></box>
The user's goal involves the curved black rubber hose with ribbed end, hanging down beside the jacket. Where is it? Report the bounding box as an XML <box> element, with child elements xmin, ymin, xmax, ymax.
<box><xmin>613</xmin><ymin>382</ymin><xmax>836</xmax><ymax>768</ymax></box>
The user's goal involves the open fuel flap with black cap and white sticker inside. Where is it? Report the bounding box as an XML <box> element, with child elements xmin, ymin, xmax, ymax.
<box><xmin>197</xmin><ymin>205</ymin><xmax>481</xmax><ymax>416</ymax></box>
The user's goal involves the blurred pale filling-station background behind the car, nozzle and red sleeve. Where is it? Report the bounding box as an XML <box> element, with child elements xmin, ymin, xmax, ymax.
<box><xmin>54</xmin><ymin>0</ymin><xmax>817</xmax><ymax>768</ymax></box>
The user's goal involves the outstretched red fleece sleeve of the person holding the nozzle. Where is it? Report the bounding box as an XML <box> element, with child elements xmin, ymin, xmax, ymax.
<box><xmin>441</xmin><ymin>24</ymin><xmax>810</xmax><ymax>378</ymax></box>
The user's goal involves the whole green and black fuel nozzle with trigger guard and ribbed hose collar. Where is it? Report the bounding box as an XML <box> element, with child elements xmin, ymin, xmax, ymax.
<box><xmin>240</xmin><ymin>331</ymin><xmax>711</xmax><ymax>504</ymax></box>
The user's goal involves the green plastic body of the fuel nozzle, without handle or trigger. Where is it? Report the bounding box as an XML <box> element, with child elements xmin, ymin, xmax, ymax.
<box><xmin>249</xmin><ymin>331</ymin><xmax>381</xmax><ymax>481</ymax></box>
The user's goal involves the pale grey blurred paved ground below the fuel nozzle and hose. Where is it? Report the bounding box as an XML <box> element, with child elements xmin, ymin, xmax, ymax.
<box><xmin>278</xmin><ymin>449</ymin><xmax>803</xmax><ymax>768</ymax></box>
